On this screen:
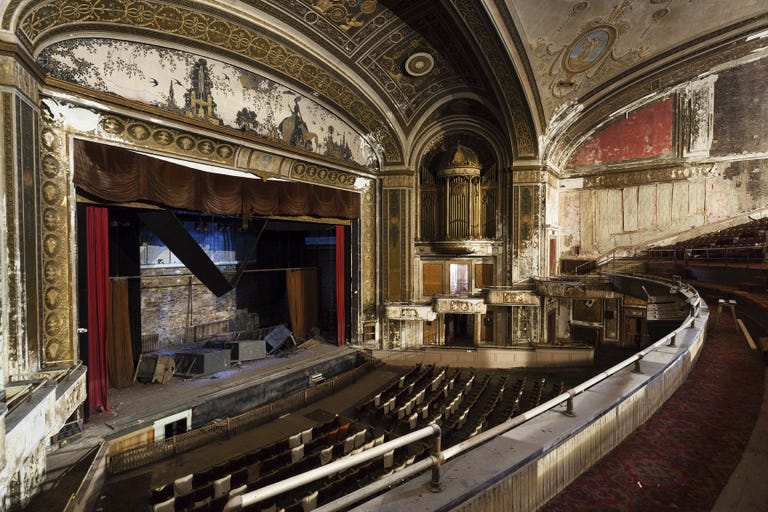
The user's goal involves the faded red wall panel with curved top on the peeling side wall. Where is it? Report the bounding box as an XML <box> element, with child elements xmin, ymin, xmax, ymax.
<box><xmin>570</xmin><ymin>98</ymin><xmax>673</xmax><ymax>166</ymax></box>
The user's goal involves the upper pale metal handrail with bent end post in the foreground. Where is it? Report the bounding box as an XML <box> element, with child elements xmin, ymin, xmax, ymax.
<box><xmin>224</xmin><ymin>423</ymin><xmax>440</xmax><ymax>512</ymax></box>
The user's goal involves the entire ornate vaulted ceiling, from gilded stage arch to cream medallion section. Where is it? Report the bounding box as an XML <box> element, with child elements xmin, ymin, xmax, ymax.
<box><xmin>0</xmin><ymin>0</ymin><xmax>768</xmax><ymax>169</ymax></box>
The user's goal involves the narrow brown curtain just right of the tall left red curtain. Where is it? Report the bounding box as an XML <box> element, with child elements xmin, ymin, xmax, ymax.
<box><xmin>107</xmin><ymin>279</ymin><xmax>134</xmax><ymax>389</ymax></box>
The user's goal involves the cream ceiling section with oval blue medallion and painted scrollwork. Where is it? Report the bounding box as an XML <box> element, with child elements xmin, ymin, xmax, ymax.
<box><xmin>507</xmin><ymin>0</ymin><xmax>768</xmax><ymax>120</ymax></box>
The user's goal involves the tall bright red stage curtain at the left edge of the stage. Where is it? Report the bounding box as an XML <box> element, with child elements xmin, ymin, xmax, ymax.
<box><xmin>85</xmin><ymin>206</ymin><xmax>109</xmax><ymax>410</ymax></box>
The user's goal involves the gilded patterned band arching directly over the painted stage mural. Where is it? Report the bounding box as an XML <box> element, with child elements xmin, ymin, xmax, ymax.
<box><xmin>16</xmin><ymin>0</ymin><xmax>402</xmax><ymax>162</ymax></box>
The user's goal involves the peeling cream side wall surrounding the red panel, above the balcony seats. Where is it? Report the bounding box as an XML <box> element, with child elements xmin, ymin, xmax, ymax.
<box><xmin>558</xmin><ymin>55</ymin><xmax>768</xmax><ymax>255</ymax></box>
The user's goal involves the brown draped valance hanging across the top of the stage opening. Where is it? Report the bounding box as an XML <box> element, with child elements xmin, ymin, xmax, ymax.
<box><xmin>74</xmin><ymin>140</ymin><xmax>360</xmax><ymax>219</ymax></box>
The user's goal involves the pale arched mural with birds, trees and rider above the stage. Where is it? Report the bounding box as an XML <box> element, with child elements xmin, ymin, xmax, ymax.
<box><xmin>37</xmin><ymin>39</ymin><xmax>379</xmax><ymax>169</ymax></box>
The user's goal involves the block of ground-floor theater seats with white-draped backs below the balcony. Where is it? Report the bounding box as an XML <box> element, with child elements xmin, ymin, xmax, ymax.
<box><xmin>150</xmin><ymin>365</ymin><xmax>564</xmax><ymax>512</ymax></box>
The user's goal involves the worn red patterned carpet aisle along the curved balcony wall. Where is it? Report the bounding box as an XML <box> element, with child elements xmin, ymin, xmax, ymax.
<box><xmin>542</xmin><ymin>308</ymin><xmax>765</xmax><ymax>512</ymax></box>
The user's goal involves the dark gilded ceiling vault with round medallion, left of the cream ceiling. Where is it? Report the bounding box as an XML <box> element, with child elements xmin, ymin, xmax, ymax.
<box><xmin>3</xmin><ymin>0</ymin><xmax>534</xmax><ymax>165</ymax></box>
